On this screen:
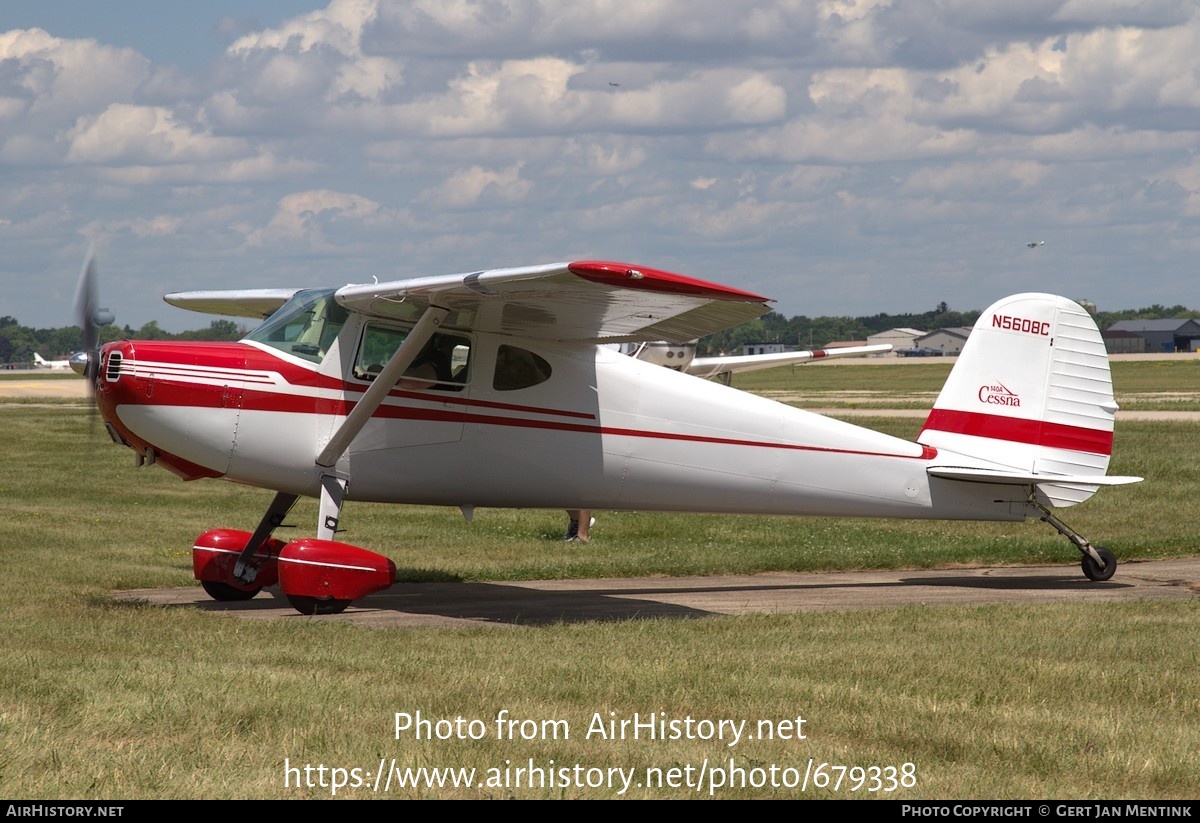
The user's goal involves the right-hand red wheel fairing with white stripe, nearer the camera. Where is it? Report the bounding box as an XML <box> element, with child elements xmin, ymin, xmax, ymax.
<box><xmin>278</xmin><ymin>537</ymin><xmax>396</xmax><ymax>602</ymax></box>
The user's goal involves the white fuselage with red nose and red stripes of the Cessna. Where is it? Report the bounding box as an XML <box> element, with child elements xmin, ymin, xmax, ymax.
<box><xmin>102</xmin><ymin>324</ymin><xmax>1026</xmax><ymax>519</ymax></box>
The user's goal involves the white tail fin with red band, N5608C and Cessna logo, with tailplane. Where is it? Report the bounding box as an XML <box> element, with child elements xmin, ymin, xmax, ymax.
<box><xmin>917</xmin><ymin>294</ymin><xmax>1136</xmax><ymax>506</ymax></box>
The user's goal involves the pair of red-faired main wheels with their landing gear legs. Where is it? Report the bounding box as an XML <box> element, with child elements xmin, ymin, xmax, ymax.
<box><xmin>192</xmin><ymin>487</ymin><xmax>396</xmax><ymax>614</ymax></box>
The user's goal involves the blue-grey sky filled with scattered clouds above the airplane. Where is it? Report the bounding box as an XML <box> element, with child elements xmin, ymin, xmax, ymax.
<box><xmin>0</xmin><ymin>0</ymin><xmax>1200</xmax><ymax>331</ymax></box>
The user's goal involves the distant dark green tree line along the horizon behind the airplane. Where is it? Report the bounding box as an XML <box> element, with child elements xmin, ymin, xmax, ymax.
<box><xmin>0</xmin><ymin>302</ymin><xmax>1200</xmax><ymax>365</ymax></box>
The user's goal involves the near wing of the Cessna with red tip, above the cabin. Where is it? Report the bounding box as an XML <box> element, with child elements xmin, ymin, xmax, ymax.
<box><xmin>336</xmin><ymin>260</ymin><xmax>770</xmax><ymax>343</ymax></box>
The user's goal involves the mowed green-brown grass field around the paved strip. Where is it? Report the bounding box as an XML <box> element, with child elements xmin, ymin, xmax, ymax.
<box><xmin>0</xmin><ymin>370</ymin><xmax>1200</xmax><ymax>799</ymax></box>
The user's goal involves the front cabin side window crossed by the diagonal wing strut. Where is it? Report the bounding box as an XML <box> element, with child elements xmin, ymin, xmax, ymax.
<box><xmin>354</xmin><ymin>323</ymin><xmax>470</xmax><ymax>391</ymax></box>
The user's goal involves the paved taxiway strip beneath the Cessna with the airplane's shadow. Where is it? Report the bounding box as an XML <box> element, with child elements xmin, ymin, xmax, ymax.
<box><xmin>114</xmin><ymin>558</ymin><xmax>1200</xmax><ymax>629</ymax></box>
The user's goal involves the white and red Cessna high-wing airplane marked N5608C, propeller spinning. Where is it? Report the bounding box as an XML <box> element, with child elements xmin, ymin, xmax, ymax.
<box><xmin>73</xmin><ymin>258</ymin><xmax>1140</xmax><ymax>614</ymax></box>
